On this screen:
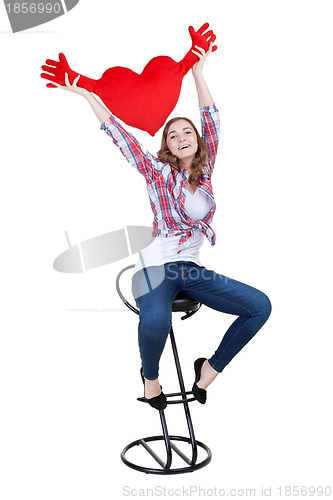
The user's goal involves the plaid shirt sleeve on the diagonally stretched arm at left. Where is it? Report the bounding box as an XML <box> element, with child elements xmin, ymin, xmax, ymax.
<box><xmin>101</xmin><ymin>114</ymin><xmax>164</xmax><ymax>183</ymax></box>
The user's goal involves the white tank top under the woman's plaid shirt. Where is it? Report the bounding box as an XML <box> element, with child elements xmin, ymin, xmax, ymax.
<box><xmin>133</xmin><ymin>187</ymin><xmax>212</xmax><ymax>274</ymax></box>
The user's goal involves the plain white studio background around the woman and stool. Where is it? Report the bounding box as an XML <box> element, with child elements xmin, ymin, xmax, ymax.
<box><xmin>0</xmin><ymin>0</ymin><xmax>333</xmax><ymax>500</ymax></box>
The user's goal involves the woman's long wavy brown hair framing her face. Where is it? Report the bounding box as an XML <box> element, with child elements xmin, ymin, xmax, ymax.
<box><xmin>157</xmin><ymin>117</ymin><xmax>209</xmax><ymax>185</ymax></box>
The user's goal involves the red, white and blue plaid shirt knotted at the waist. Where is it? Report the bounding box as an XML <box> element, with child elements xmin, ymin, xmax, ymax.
<box><xmin>101</xmin><ymin>105</ymin><xmax>220</xmax><ymax>252</ymax></box>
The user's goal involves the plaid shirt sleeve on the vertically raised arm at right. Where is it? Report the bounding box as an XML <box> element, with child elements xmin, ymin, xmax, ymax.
<box><xmin>200</xmin><ymin>104</ymin><xmax>220</xmax><ymax>174</ymax></box>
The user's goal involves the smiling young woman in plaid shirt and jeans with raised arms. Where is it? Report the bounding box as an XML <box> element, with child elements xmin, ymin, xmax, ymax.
<box><xmin>53</xmin><ymin>44</ymin><xmax>271</xmax><ymax>409</ymax></box>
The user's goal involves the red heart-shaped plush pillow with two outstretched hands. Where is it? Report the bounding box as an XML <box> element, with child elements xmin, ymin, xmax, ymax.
<box><xmin>41</xmin><ymin>23</ymin><xmax>217</xmax><ymax>135</ymax></box>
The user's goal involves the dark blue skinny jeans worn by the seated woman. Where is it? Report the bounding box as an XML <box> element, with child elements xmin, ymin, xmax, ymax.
<box><xmin>132</xmin><ymin>261</ymin><xmax>271</xmax><ymax>380</ymax></box>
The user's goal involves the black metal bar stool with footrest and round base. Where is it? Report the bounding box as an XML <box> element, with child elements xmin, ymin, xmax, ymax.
<box><xmin>116</xmin><ymin>265</ymin><xmax>212</xmax><ymax>474</ymax></box>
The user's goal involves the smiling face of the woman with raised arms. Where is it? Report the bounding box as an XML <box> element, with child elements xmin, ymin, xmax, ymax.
<box><xmin>167</xmin><ymin>118</ymin><xmax>198</xmax><ymax>160</ymax></box>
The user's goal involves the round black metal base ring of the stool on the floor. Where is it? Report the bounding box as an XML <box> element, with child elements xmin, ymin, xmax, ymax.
<box><xmin>120</xmin><ymin>436</ymin><xmax>212</xmax><ymax>474</ymax></box>
